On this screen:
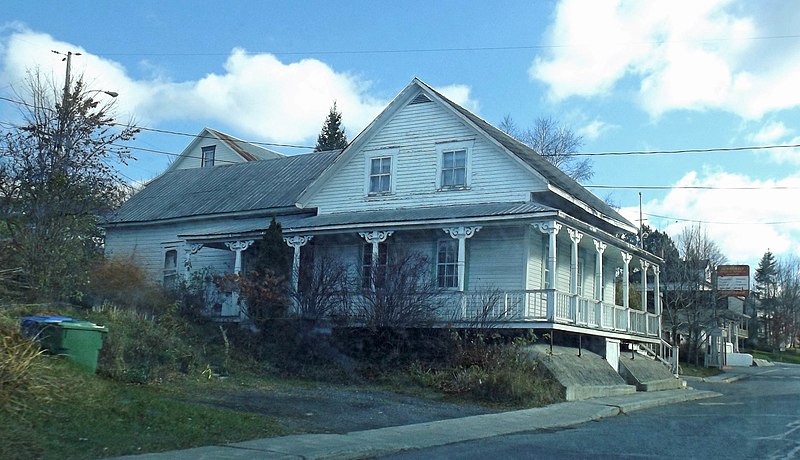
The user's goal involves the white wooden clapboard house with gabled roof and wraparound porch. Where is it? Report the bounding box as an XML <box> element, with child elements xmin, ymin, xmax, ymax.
<box><xmin>106</xmin><ymin>79</ymin><xmax>660</xmax><ymax>352</ymax></box>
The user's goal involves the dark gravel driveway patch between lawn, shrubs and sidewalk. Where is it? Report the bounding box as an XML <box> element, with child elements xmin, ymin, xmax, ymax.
<box><xmin>181</xmin><ymin>386</ymin><xmax>498</xmax><ymax>433</ymax></box>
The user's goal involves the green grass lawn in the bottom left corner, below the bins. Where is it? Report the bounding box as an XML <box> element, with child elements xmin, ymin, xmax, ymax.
<box><xmin>0</xmin><ymin>357</ymin><xmax>287</xmax><ymax>459</ymax></box>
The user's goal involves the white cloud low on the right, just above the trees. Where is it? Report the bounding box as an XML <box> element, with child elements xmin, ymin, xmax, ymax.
<box><xmin>621</xmin><ymin>170</ymin><xmax>800</xmax><ymax>264</ymax></box>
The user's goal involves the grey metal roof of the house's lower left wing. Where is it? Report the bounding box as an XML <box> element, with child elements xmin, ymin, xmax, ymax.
<box><xmin>106</xmin><ymin>150</ymin><xmax>341</xmax><ymax>224</ymax></box>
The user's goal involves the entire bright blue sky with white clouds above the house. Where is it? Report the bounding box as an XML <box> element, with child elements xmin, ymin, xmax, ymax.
<box><xmin>0</xmin><ymin>0</ymin><xmax>800</xmax><ymax>265</ymax></box>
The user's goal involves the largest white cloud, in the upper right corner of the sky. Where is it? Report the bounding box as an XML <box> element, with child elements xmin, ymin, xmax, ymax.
<box><xmin>529</xmin><ymin>0</ymin><xmax>800</xmax><ymax>118</ymax></box>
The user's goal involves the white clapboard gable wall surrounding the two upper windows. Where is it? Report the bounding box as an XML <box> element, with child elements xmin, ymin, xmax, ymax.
<box><xmin>309</xmin><ymin>103</ymin><xmax>544</xmax><ymax>214</ymax></box>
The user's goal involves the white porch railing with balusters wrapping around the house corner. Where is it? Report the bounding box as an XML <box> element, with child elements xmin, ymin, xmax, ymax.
<box><xmin>460</xmin><ymin>289</ymin><xmax>660</xmax><ymax>337</ymax></box>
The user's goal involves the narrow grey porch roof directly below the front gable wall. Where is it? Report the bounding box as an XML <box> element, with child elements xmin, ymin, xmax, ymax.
<box><xmin>283</xmin><ymin>202</ymin><xmax>557</xmax><ymax>232</ymax></box>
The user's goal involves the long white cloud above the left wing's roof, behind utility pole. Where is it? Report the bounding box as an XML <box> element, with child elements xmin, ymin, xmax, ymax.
<box><xmin>0</xmin><ymin>26</ymin><xmax>388</xmax><ymax>142</ymax></box>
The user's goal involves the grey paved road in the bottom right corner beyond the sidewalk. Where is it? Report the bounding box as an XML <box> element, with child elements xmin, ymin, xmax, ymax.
<box><xmin>386</xmin><ymin>365</ymin><xmax>800</xmax><ymax>459</ymax></box>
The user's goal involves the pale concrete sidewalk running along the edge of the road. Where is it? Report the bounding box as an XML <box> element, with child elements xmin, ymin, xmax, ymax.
<box><xmin>115</xmin><ymin>389</ymin><xmax>720</xmax><ymax>460</ymax></box>
